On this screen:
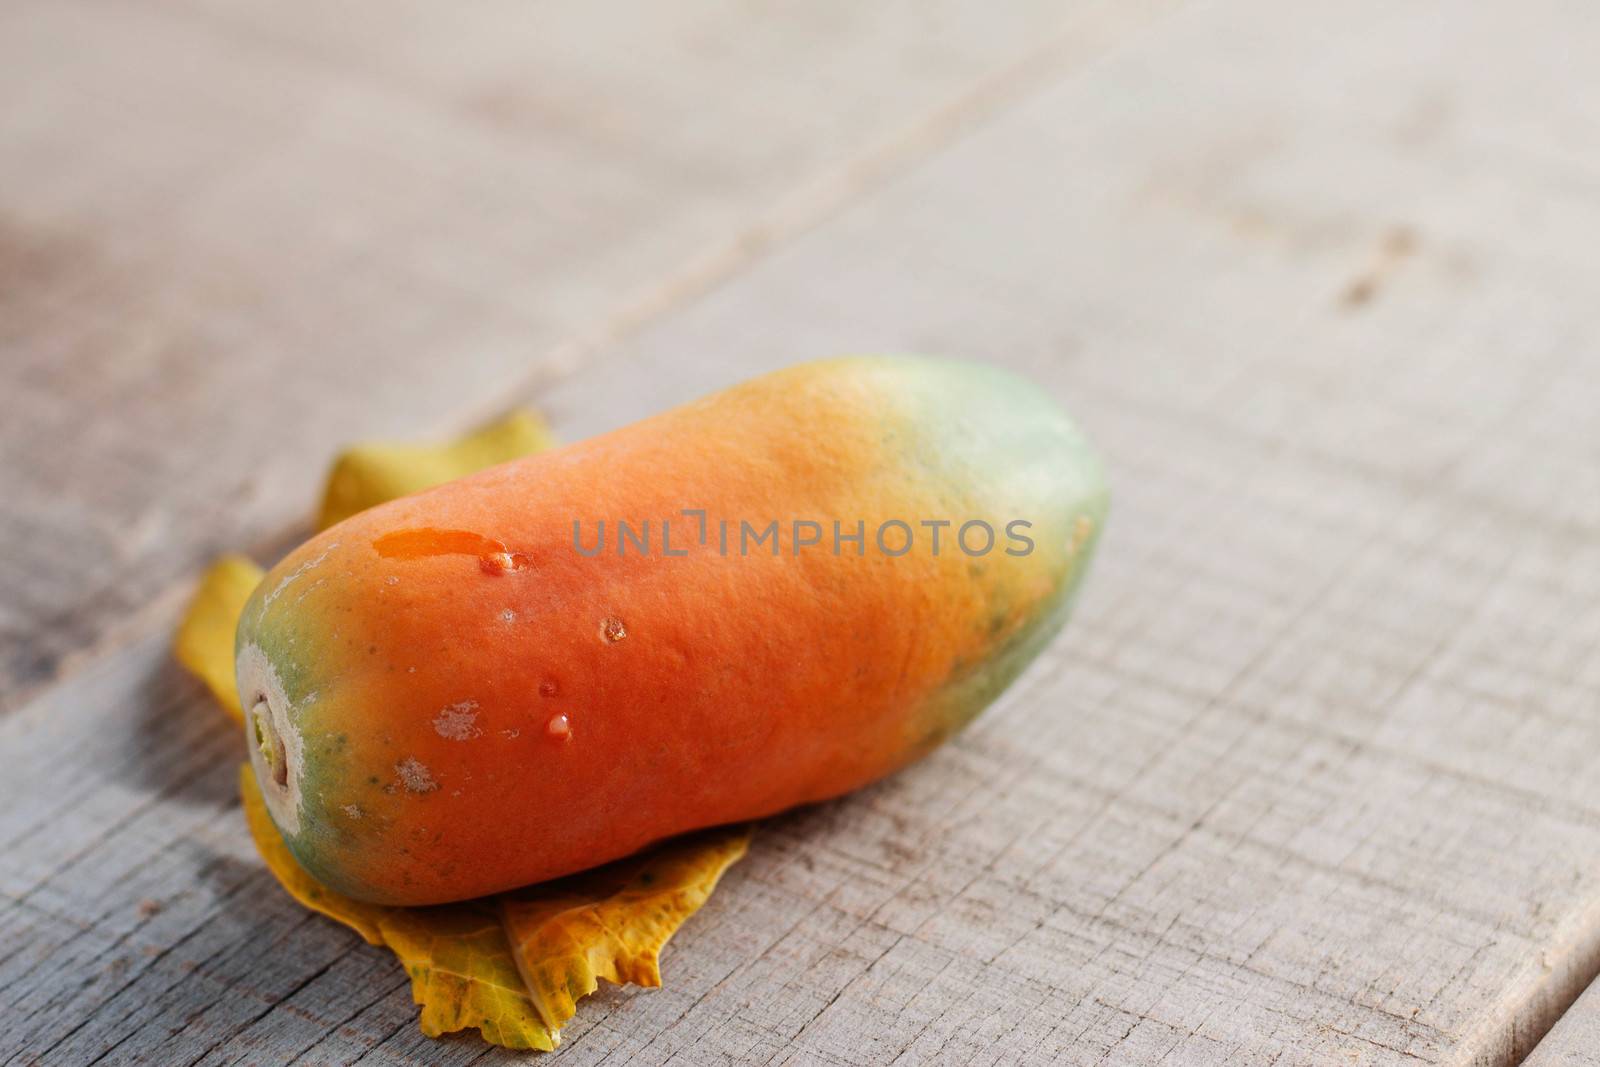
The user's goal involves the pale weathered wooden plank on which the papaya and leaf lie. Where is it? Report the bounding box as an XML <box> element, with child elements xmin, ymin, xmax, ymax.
<box><xmin>0</xmin><ymin>0</ymin><xmax>1600</xmax><ymax>1067</ymax></box>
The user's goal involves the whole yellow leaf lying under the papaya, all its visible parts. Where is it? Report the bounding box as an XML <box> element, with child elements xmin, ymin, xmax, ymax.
<box><xmin>176</xmin><ymin>414</ymin><xmax>750</xmax><ymax>1051</ymax></box>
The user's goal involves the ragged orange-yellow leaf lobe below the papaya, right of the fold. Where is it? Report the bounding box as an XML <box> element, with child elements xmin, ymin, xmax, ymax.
<box><xmin>499</xmin><ymin>827</ymin><xmax>750</xmax><ymax>1030</ymax></box>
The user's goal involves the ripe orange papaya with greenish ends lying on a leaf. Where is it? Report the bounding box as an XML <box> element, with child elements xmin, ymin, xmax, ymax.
<box><xmin>235</xmin><ymin>357</ymin><xmax>1107</xmax><ymax>905</ymax></box>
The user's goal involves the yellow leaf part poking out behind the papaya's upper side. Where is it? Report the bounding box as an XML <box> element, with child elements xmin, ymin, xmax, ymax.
<box><xmin>317</xmin><ymin>411</ymin><xmax>555</xmax><ymax>530</ymax></box>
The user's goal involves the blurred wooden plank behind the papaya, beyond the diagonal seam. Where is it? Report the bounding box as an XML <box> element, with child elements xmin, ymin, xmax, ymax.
<box><xmin>0</xmin><ymin>0</ymin><xmax>1170</xmax><ymax>707</ymax></box>
